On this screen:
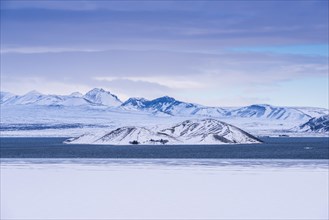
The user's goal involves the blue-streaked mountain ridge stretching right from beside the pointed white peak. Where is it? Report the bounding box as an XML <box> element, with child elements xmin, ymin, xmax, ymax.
<box><xmin>121</xmin><ymin>99</ymin><xmax>318</xmax><ymax>121</ymax></box>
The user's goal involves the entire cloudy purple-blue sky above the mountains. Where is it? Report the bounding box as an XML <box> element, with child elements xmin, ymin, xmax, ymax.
<box><xmin>1</xmin><ymin>0</ymin><xmax>329</xmax><ymax>108</ymax></box>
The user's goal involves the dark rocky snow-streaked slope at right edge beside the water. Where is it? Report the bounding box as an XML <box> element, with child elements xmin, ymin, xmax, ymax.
<box><xmin>299</xmin><ymin>115</ymin><xmax>329</xmax><ymax>132</ymax></box>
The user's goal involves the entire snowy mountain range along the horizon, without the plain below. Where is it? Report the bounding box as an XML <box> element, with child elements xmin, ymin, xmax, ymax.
<box><xmin>0</xmin><ymin>88</ymin><xmax>329</xmax><ymax>129</ymax></box>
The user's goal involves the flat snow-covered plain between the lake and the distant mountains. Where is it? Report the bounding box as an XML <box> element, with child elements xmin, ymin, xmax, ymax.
<box><xmin>0</xmin><ymin>105</ymin><xmax>328</xmax><ymax>137</ymax></box>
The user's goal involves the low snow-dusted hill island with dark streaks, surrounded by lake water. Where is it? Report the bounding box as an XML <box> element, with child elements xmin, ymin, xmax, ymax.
<box><xmin>65</xmin><ymin>118</ymin><xmax>261</xmax><ymax>145</ymax></box>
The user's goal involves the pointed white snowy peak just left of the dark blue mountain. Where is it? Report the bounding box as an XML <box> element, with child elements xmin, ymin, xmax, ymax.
<box><xmin>83</xmin><ymin>88</ymin><xmax>122</xmax><ymax>106</ymax></box>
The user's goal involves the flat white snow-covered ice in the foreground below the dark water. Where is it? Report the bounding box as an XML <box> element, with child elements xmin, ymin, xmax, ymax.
<box><xmin>1</xmin><ymin>159</ymin><xmax>329</xmax><ymax>219</ymax></box>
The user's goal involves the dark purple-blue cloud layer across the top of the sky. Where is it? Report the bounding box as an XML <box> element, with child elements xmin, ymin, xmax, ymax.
<box><xmin>1</xmin><ymin>1</ymin><xmax>328</xmax><ymax>51</ymax></box>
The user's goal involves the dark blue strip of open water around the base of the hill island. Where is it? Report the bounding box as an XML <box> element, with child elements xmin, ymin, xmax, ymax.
<box><xmin>0</xmin><ymin>137</ymin><xmax>329</xmax><ymax>159</ymax></box>
